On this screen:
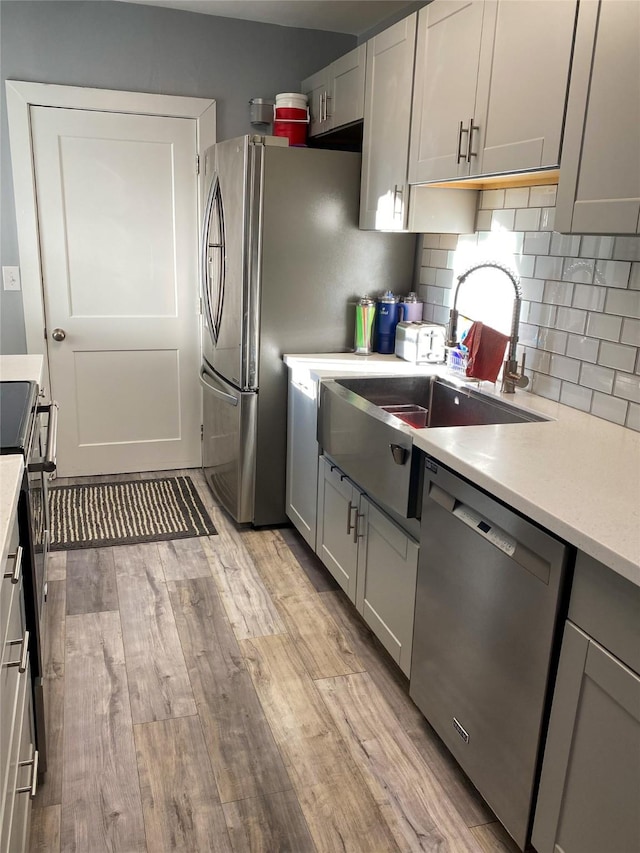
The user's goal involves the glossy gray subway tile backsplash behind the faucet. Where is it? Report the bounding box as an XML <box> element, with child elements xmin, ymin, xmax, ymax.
<box><xmin>419</xmin><ymin>186</ymin><xmax>640</xmax><ymax>431</ymax></box>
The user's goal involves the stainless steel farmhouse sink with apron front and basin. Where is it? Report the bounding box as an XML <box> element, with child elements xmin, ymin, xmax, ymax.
<box><xmin>318</xmin><ymin>376</ymin><xmax>546</xmax><ymax>518</ymax></box>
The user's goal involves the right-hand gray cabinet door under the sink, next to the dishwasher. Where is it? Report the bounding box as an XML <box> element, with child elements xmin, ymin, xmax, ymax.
<box><xmin>356</xmin><ymin>496</ymin><xmax>419</xmax><ymax>676</ymax></box>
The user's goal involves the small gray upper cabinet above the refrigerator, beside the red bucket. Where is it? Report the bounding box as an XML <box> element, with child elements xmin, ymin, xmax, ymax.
<box><xmin>301</xmin><ymin>44</ymin><xmax>367</xmax><ymax>136</ymax></box>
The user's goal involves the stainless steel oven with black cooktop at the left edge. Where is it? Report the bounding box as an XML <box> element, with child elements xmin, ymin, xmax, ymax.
<box><xmin>0</xmin><ymin>382</ymin><xmax>58</xmax><ymax>772</ymax></box>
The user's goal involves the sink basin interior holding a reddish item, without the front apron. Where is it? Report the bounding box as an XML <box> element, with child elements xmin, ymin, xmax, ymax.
<box><xmin>335</xmin><ymin>376</ymin><xmax>547</xmax><ymax>427</ymax></box>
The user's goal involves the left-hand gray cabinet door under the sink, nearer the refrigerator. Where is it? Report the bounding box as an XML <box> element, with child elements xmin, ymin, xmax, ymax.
<box><xmin>317</xmin><ymin>456</ymin><xmax>360</xmax><ymax>602</ymax></box>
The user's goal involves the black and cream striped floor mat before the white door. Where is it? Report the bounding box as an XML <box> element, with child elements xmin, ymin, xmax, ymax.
<box><xmin>49</xmin><ymin>477</ymin><xmax>217</xmax><ymax>551</ymax></box>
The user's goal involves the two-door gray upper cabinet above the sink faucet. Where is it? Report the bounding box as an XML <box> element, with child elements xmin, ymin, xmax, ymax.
<box><xmin>409</xmin><ymin>0</ymin><xmax>576</xmax><ymax>183</ymax></box>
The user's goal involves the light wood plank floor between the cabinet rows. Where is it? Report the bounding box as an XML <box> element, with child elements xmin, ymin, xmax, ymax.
<box><xmin>31</xmin><ymin>470</ymin><xmax>517</xmax><ymax>853</ymax></box>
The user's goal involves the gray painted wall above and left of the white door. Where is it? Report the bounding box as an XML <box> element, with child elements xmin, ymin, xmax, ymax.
<box><xmin>0</xmin><ymin>0</ymin><xmax>356</xmax><ymax>353</ymax></box>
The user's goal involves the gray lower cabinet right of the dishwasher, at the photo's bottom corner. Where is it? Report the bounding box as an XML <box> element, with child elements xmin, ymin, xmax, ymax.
<box><xmin>532</xmin><ymin>555</ymin><xmax>640</xmax><ymax>853</ymax></box>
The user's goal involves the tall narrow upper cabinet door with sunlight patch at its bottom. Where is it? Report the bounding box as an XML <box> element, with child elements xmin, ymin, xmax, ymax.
<box><xmin>360</xmin><ymin>13</ymin><xmax>417</xmax><ymax>231</ymax></box>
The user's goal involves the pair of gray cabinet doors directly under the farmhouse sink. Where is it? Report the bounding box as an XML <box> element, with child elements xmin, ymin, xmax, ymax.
<box><xmin>318</xmin><ymin>456</ymin><xmax>419</xmax><ymax>676</ymax></box>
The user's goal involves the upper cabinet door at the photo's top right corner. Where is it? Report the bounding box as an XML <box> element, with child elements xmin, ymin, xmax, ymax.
<box><xmin>555</xmin><ymin>0</ymin><xmax>640</xmax><ymax>234</ymax></box>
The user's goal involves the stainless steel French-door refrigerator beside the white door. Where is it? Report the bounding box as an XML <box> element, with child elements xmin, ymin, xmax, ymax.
<box><xmin>200</xmin><ymin>136</ymin><xmax>415</xmax><ymax>526</ymax></box>
